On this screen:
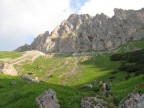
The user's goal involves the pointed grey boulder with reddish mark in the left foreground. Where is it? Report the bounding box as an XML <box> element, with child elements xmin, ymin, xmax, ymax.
<box><xmin>36</xmin><ymin>89</ymin><xmax>60</xmax><ymax>108</ymax></box>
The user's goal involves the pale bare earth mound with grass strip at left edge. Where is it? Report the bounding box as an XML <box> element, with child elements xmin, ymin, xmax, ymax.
<box><xmin>0</xmin><ymin>51</ymin><xmax>45</xmax><ymax>76</ymax></box>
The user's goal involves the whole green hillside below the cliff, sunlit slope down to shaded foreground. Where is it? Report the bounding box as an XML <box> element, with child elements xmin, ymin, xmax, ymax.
<box><xmin>0</xmin><ymin>40</ymin><xmax>144</xmax><ymax>108</ymax></box>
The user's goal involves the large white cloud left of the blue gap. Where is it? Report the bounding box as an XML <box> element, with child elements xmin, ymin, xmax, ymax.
<box><xmin>0</xmin><ymin>0</ymin><xmax>71</xmax><ymax>50</ymax></box>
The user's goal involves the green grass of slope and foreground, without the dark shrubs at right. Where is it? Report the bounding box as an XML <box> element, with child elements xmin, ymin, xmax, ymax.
<box><xmin>0</xmin><ymin>41</ymin><xmax>144</xmax><ymax>108</ymax></box>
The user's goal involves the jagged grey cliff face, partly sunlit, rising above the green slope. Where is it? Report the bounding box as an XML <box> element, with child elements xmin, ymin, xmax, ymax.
<box><xmin>18</xmin><ymin>8</ymin><xmax>144</xmax><ymax>52</ymax></box>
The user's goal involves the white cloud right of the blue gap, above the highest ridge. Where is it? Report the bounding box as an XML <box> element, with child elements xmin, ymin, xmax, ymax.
<box><xmin>78</xmin><ymin>0</ymin><xmax>144</xmax><ymax>17</ymax></box>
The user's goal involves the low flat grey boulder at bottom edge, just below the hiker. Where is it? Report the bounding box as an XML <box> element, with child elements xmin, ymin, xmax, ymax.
<box><xmin>81</xmin><ymin>97</ymin><xmax>108</xmax><ymax>108</ymax></box>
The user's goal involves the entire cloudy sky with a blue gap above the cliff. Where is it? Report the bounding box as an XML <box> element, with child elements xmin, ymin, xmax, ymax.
<box><xmin>0</xmin><ymin>0</ymin><xmax>144</xmax><ymax>51</ymax></box>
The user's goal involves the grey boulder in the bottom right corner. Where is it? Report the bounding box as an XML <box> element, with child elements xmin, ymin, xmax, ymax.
<box><xmin>119</xmin><ymin>92</ymin><xmax>144</xmax><ymax>108</ymax></box>
